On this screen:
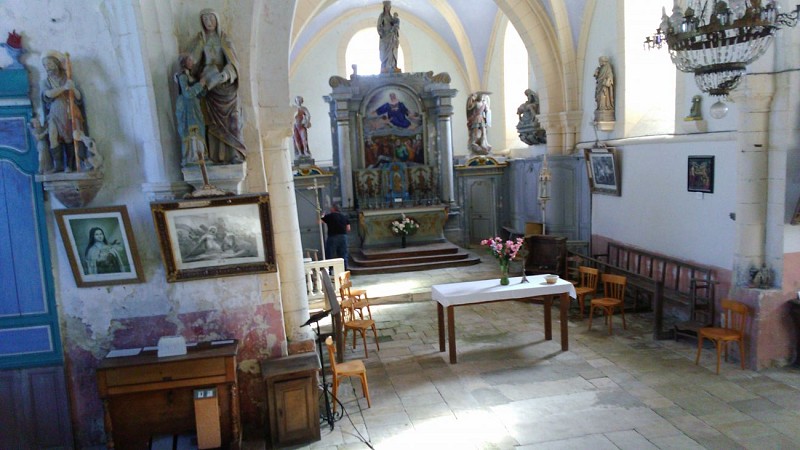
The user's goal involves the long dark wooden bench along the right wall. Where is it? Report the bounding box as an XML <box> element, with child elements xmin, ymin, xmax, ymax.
<box><xmin>570</xmin><ymin>242</ymin><xmax>717</xmax><ymax>339</ymax></box>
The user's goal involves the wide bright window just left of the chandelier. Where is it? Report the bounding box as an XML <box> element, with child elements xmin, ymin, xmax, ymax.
<box><xmin>617</xmin><ymin>0</ymin><xmax>676</xmax><ymax>136</ymax></box>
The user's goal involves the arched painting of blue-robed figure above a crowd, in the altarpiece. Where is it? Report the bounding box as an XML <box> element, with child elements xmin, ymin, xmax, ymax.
<box><xmin>361</xmin><ymin>86</ymin><xmax>425</xmax><ymax>168</ymax></box>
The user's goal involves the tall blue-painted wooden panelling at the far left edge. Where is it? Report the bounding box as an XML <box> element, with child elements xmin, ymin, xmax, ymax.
<box><xmin>0</xmin><ymin>74</ymin><xmax>74</xmax><ymax>449</ymax></box>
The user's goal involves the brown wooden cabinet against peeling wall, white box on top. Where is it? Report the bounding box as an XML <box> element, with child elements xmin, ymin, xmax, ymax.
<box><xmin>97</xmin><ymin>341</ymin><xmax>241</xmax><ymax>449</ymax></box>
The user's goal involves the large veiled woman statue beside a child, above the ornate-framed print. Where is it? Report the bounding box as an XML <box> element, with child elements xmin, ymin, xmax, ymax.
<box><xmin>190</xmin><ymin>9</ymin><xmax>247</xmax><ymax>164</ymax></box>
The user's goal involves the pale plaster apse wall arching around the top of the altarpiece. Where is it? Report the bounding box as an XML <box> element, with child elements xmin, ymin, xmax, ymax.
<box><xmin>286</xmin><ymin>12</ymin><xmax>468</xmax><ymax>166</ymax></box>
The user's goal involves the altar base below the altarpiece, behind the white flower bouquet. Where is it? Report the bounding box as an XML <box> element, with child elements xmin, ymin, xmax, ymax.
<box><xmin>358</xmin><ymin>205</ymin><xmax>448</xmax><ymax>249</ymax></box>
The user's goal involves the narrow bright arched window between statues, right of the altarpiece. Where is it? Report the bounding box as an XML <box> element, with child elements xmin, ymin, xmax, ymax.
<box><xmin>498</xmin><ymin>22</ymin><xmax>530</xmax><ymax>148</ymax></box>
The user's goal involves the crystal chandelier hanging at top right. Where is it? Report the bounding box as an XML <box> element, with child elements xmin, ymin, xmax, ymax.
<box><xmin>644</xmin><ymin>0</ymin><xmax>800</xmax><ymax>118</ymax></box>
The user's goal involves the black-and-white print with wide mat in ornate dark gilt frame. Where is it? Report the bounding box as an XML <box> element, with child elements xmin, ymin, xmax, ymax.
<box><xmin>150</xmin><ymin>194</ymin><xmax>276</xmax><ymax>282</ymax></box>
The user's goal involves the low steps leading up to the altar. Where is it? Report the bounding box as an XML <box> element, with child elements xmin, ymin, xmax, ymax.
<box><xmin>348</xmin><ymin>242</ymin><xmax>481</xmax><ymax>275</ymax></box>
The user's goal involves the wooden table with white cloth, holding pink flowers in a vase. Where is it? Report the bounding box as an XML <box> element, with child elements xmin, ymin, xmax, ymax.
<box><xmin>431</xmin><ymin>275</ymin><xmax>575</xmax><ymax>364</ymax></box>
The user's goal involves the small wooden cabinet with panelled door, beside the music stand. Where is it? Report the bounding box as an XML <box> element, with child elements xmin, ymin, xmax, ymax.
<box><xmin>261</xmin><ymin>353</ymin><xmax>320</xmax><ymax>447</ymax></box>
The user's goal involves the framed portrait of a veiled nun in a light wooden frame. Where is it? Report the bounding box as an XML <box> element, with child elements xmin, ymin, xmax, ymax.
<box><xmin>54</xmin><ymin>206</ymin><xmax>144</xmax><ymax>287</ymax></box>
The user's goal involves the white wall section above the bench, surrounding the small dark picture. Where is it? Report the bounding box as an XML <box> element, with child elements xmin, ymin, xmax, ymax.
<box><xmin>592</xmin><ymin>139</ymin><xmax>738</xmax><ymax>268</ymax></box>
